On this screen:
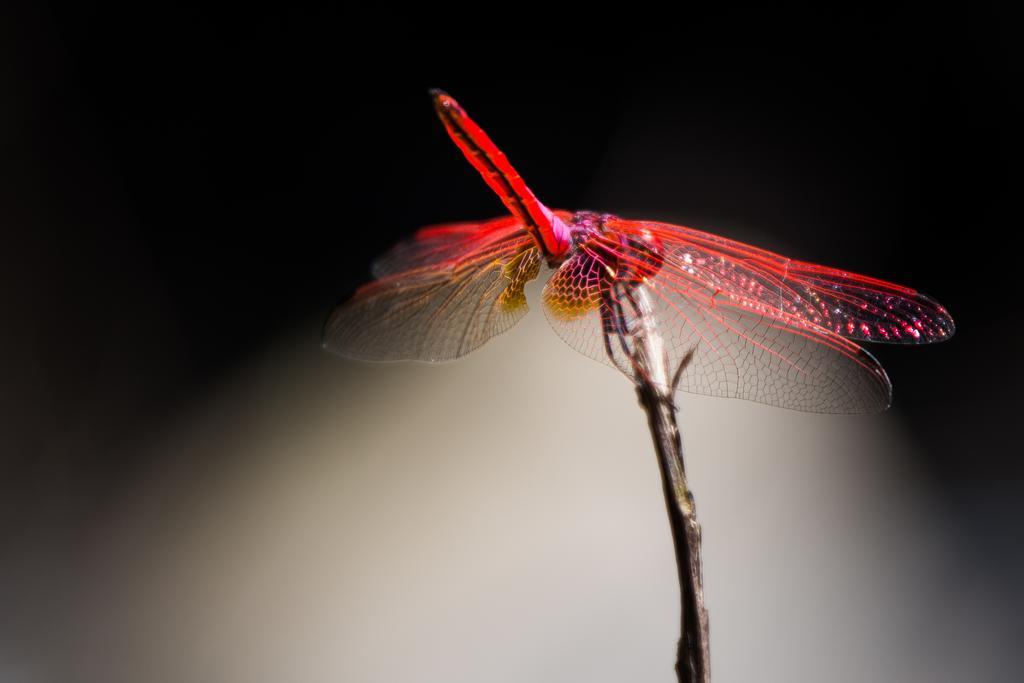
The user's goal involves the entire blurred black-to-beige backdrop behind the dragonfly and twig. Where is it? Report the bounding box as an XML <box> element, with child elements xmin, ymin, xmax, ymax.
<box><xmin>0</xmin><ymin>5</ymin><xmax>1024</xmax><ymax>683</ymax></box>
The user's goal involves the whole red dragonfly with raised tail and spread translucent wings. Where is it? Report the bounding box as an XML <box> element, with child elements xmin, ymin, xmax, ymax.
<box><xmin>324</xmin><ymin>90</ymin><xmax>954</xmax><ymax>413</ymax></box>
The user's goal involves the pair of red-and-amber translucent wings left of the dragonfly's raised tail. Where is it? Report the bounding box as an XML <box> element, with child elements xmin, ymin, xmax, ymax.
<box><xmin>324</xmin><ymin>218</ymin><xmax>541</xmax><ymax>360</ymax></box>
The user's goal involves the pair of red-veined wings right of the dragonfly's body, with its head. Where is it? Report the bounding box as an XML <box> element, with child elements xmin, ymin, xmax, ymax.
<box><xmin>544</xmin><ymin>219</ymin><xmax>953</xmax><ymax>413</ymax></box>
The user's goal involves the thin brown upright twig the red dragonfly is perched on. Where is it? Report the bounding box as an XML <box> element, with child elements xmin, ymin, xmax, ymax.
<box><xmin>603</xmin><ymin>286</ymin><xmax>711</xmax><ymax>683</ymax></box>
